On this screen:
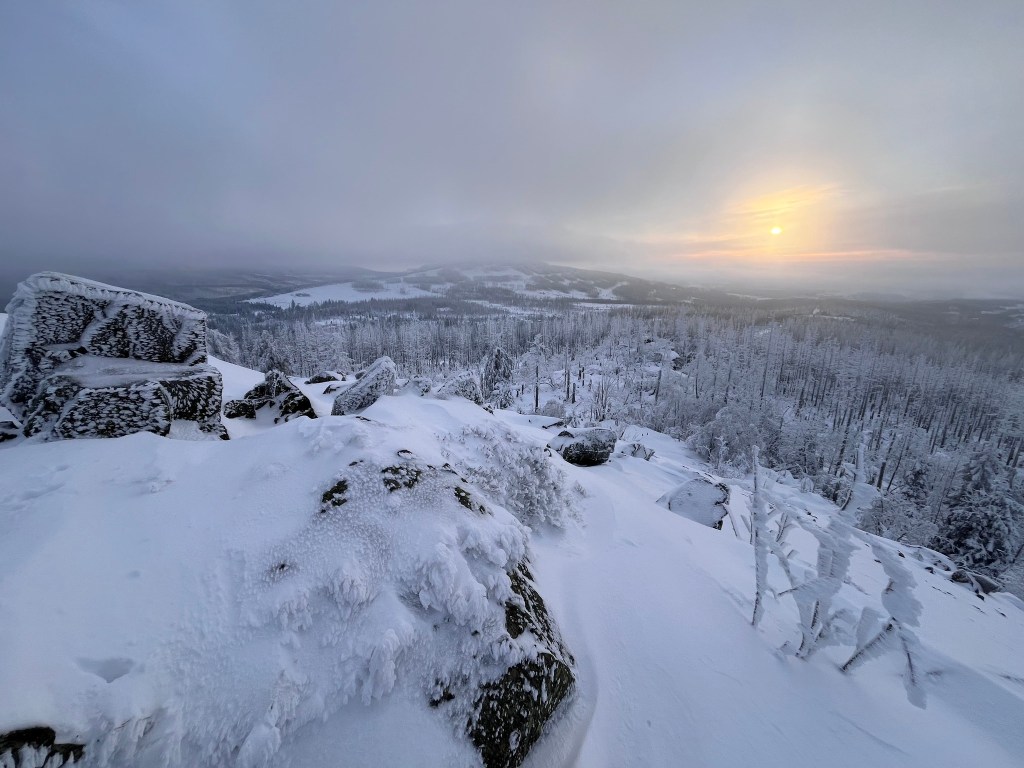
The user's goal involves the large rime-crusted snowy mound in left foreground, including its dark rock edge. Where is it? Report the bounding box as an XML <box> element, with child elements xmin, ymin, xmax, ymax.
<box><xmin>0</xmin><ymin>405</ymin><xmax>574</xmax><ymax>768</ymax></box>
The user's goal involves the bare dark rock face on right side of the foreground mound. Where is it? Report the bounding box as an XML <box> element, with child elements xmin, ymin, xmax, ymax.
<box><xmin>467</xmin><ymin>561</ymin><xmax>575</xmax><ymax>768</ymax></box>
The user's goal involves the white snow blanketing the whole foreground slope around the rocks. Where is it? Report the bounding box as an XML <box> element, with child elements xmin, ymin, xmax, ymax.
<box><xmin>0</xmin><ymin>360</ymin><xmax>1024</xmax><ymax>768</ymax></box>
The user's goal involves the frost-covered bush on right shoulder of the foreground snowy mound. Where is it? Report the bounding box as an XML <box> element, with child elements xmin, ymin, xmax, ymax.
<box><xmin>443</xmin><ymin>423</ymin><xmax>575</xmax><ymax>526</ymax></box>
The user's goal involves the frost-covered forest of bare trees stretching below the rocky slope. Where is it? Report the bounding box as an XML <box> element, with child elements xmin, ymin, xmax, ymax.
<box><xmin>211</xmin><ymin>302</ymin><xmax>1024</xmax><ymax>593</ymax></box>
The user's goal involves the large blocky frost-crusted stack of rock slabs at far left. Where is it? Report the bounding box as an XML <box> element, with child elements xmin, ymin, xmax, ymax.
<box><xmin>0</xmin><ymin>272</ymin><xmax>226</xmax><ymax>439</ymax></box>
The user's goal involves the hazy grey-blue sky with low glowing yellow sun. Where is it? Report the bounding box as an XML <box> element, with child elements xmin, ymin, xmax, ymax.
<box><xmin>0</xmin><ymin>0</ymin><xmax>1024</xmax><ymax>297</ymax></box>
